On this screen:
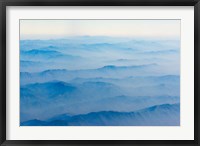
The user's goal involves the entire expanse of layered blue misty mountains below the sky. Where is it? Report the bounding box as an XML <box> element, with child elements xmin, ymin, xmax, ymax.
<box><xmin>20</xmin><ymin>36</ymin><xmax>180</xmax><ymax>126</ymax></box>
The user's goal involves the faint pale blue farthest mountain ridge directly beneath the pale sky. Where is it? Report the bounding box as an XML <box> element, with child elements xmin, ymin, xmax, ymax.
<box><xmin>20</xmin><ymin>36</ymin><xmax>180</xmax><ymax>50</ymax></box>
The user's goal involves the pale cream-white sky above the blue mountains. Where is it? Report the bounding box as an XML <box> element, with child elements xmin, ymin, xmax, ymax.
<box><xmin>20</xmin><ymin>20</ymin><xmax>181</xmax><ymax>39</ymax></box>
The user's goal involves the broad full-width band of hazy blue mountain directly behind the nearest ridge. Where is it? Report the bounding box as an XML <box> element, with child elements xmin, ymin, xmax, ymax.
<box><xmin>20</xmin><ymin>78</ymin><xmax>180</xmax><ymax>121</ymax></box>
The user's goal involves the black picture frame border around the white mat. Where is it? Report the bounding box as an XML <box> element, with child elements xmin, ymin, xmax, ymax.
<box><xmin>0</xmin><ymin>0</ymin><xmax>200</xmax><ymax>146</ymax></box>
